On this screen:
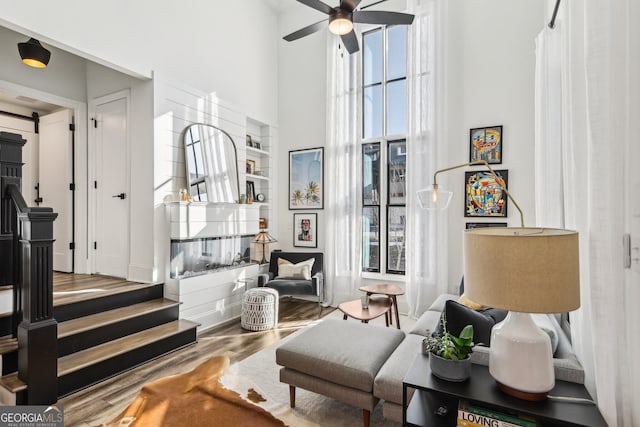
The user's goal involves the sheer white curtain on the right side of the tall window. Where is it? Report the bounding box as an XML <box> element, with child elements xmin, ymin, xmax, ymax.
<box><xmin>406</xmin><ymin>0</ymin><xmax>447</xmax><ymax>317</ymax></box>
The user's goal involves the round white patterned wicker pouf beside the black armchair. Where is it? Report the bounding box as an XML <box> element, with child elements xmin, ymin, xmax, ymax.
<box><xmin>240</xmin><ymin>288</ymin><xmax>279</xmax><ymax>331</ymax></box>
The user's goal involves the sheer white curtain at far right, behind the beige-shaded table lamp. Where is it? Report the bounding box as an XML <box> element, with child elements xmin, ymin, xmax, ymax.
<box><xmin>536</xmin><ymin>0</ymin><xmax>640</xmax><ymax>426</ymax></box>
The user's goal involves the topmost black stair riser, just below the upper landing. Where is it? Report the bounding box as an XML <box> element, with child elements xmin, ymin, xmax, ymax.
<box><xmin>53</xmin><ymin>284</ymin><xmax>164</xmax><ymax>322</ymax></box>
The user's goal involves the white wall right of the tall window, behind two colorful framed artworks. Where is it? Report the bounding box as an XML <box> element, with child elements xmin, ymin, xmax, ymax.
<box><xmin>439</xmin><ymin>0</ymin><xmax>546</xmax><ymax>291</ymax></box>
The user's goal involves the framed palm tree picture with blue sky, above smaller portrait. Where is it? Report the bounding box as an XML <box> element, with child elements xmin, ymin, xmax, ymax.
<box><xmin>289</xmin><ymin>148</ymin><xmax>324</xmax><ymax>209</ymax></box>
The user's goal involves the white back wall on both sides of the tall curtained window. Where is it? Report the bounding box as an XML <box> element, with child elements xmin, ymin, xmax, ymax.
<box><xmin>276</xmin><ymin>0</ymin><xmax>545</xmax><ymax>298</ymax></box>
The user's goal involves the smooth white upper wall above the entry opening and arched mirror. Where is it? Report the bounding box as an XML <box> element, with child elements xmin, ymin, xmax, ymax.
<box><xmin>0</xmin><ymin>0</ymin><xmax>279</xmax><ymax>123</ymax></box>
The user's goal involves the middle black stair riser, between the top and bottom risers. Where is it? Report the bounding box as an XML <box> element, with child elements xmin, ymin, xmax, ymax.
<box><xmin>58</xmin><ymin>305</ymin><xmax>179</xmax><ymax>357</ymax></box>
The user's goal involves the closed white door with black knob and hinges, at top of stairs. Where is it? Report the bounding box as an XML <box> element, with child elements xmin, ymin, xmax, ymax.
<box><xmin>90</xmin><ymin>96</ymin><xmax>129</xmax><ymax>277</ymax></box>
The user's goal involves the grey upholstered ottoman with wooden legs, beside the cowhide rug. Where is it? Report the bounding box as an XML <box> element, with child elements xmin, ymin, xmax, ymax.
<box><xmin>276</xmin><ymin>319</ymin><xmax>405</xmax><ymax>427</ymax></box>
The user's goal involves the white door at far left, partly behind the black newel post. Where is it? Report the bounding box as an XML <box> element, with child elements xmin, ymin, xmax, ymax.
<box><xmin>39</xmin><ymin>110</ymin><xmax>73</xmax><ymax>273</ymax></box>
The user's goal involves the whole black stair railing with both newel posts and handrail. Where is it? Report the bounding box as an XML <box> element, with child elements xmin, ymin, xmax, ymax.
<box><xmin>0</xmin><ymin>132</ymin><xmax>58</xmax><ymax>405</ymax></box>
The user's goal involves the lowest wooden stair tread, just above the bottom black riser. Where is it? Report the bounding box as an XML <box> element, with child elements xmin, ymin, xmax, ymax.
<box><xmin>58</xmin><ymin>319</ymin><xmax>198</xmax><ymax>377</ymax></box>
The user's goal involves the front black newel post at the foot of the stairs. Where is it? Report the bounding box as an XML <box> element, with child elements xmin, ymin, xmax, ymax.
<box><xmin>18</xmin><ymin>208</ymin><xmax>58</xmax><ymax>405</ymax></box>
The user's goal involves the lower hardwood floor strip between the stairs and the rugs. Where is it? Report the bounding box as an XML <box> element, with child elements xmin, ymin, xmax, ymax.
<box><xmin>58</xmin><ymin>298</ymin><xmax>335</xmax><ymax>427</ymax></box>
